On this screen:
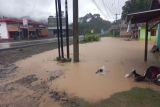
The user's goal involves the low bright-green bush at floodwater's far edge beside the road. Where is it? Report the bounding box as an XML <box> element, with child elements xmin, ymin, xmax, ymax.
<box><xmin>82</xmin><ymin>34</ymin><xmax>101</xmax><ymax>43</ymax></box>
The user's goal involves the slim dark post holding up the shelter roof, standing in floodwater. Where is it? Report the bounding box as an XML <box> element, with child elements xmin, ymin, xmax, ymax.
<box><xmin>144</xmin><ymin>21</ymin><xmax>148</xmax><ymax>62</ymax></box>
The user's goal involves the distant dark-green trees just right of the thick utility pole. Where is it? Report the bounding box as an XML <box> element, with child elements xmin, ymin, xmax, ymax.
<box><xmin>79</xmin><ymin>13</ymin><xmax>111</xmax><ymax>34</ymax></box>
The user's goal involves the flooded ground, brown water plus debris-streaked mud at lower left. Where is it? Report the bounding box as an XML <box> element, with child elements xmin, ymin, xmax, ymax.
<box><xmin>0</xmin><ymin>38</ymin><xmax>160</xmax><ymax>107</ymax></box>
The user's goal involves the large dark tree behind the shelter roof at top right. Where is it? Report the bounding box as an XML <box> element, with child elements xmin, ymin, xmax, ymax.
<box><xmin>122</xmin><ymin>0</ymin><xmax>152</xmax><ymax>19</ymax></box>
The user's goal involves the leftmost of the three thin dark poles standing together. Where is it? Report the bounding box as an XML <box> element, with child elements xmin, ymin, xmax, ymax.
<box><xmin>55</xmin><ymin>0</ymin><xmax>61</xmax><ymax>58</ymax></box>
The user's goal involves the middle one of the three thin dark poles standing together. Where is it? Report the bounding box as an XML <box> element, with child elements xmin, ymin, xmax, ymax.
<box><xmin>58</xmin><ymin>0</ymin><xmax>64</xmax><ymax>59</ymax></box>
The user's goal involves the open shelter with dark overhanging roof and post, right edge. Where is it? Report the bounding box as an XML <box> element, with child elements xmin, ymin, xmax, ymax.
<box><xmin>127</xmin><ymin>0</ymin><xmax>160</xmax><ymax>61</ymax></box>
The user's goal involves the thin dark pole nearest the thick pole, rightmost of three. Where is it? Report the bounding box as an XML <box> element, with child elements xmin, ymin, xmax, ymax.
<box><xmin>65</xmin><ymin>0</ymin><xmax>70</xmax><ymax>59</ymax></box>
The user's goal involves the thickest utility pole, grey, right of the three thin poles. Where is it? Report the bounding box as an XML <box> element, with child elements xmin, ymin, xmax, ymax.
<box><xmin>73</xmin><ymin>0</ymin><xmax>79</xmax><ymax>62</ymax></box>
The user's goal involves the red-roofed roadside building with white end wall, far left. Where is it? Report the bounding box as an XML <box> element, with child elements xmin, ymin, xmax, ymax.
<box><xmin>0</xmin><ymin>18</ymin><xmax>48</xmax><ymax>40</ymax></box>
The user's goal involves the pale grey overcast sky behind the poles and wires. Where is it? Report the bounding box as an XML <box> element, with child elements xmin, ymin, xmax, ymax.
<box><xmin>0</xmin><ymin>0</ymin><xmax>126</xmax><ymax>22</ymax></box>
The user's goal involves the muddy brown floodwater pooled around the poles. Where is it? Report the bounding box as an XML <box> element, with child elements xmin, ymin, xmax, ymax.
<box><xmin>0</xmin><ymin>38</ymin><xmax>160</xmax><ymax>107</ymax></box>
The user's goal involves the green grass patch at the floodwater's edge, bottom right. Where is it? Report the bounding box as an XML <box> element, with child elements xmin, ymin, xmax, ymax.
<box><xmin>62</xmin><ymin>88</ymin><xmax>160</xmax><ymax>107</ymax></box>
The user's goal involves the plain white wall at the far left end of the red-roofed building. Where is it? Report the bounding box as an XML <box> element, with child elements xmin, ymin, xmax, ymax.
<box><xmin>0</xmin><ymin>22</ymin><xmax>9</xmax><ymax>39</ymax></box>
